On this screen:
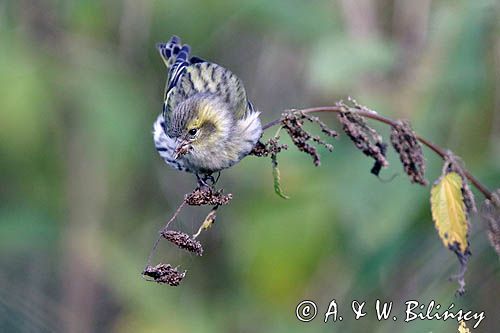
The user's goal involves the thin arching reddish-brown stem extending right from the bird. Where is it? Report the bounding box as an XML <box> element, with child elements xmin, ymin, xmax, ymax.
<box><xmin>262</xmin><ymin>106</ymin><xmax>492</xmax><ymax>200</ymax></box>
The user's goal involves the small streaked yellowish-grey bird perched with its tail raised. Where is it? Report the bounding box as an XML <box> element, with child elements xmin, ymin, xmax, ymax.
<box><xmin>153</xmin><ymin>36</ymin><xmax>262</xmax><ymax>185</ymax></box>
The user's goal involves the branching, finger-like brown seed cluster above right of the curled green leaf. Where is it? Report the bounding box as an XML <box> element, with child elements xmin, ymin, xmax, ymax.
<box><xmin>281</xmin><ymin>111</ymin><xmax>338</xmax><ymax>166</ymax></box>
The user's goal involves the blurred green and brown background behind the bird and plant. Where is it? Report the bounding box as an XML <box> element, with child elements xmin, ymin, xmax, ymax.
<box><xmin>0</xmin><ymin>0</ymin><xmax>500</xmax><ymax>333</ymax></box>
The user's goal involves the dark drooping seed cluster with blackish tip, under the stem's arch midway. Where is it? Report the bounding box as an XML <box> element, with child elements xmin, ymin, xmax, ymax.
<box><xmin>337</xmin><ymin>111</ymin><xmax>389</xmax><ymax>176</ymax></box>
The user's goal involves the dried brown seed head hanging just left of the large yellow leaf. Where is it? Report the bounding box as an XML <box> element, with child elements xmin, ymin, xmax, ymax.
<box><xmin>391</xmin><ymin>121</ymin><xmax>428</xmax><ymax>186</ymax></box>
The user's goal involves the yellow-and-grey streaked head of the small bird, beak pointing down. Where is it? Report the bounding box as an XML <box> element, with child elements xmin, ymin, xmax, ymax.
<box><xmin>165</xmin><ymin>94</ymin><xmax>233</xmax><ymax>159</ymax></box>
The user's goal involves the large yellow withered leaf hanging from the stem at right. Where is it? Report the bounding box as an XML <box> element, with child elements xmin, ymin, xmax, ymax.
<box><xmin>431</xmin><ymin>172</ymin><xmax>468</xmax><ymax>254</ymax></box>
